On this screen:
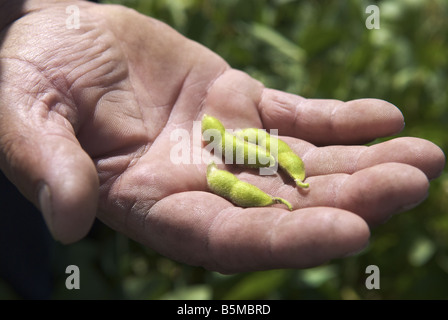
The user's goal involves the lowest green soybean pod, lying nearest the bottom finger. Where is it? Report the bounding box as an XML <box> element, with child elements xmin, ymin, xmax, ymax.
<box><xmin>207</xmin><ymin>162</ymin><xmax>292</xmax><ymax>210</ymax></box>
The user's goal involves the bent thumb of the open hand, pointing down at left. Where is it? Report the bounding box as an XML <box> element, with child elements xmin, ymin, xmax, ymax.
<box><xmin>0</xmin><ymin>119</ymin><xmax>99</xmax><ymax>243</ymax></box>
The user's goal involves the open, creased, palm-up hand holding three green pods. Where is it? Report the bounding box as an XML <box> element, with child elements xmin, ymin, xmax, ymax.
<box><xmin>0</xmin><ymin>1</ymin><xmax>445</xmax><ymax>273</ymax></box>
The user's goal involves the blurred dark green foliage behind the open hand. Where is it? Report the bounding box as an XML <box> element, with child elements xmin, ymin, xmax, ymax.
<box><xmin>0</xmin><ymin>0</ymin><xmax>448</xmax><ymax>299</ymax></box>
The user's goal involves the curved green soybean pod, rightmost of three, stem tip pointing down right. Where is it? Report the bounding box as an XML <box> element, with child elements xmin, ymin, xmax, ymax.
<box><xmin>235</xmin><ymin>128</ymin><xmax>309</xmax><ymax>188</ymax></box>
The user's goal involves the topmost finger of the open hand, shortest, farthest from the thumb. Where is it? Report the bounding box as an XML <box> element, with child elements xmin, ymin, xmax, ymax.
<box><xmin>258</xmin><ymin>89</ymin><xmax>404</xmax><ymax>145</ymax></box>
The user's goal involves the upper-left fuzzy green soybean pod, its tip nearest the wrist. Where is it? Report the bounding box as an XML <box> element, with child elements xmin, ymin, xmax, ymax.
<box><xmin>202</xmin><ymin>114</ymin><xmax>275</xmax><ymax>168</ymax></box>
